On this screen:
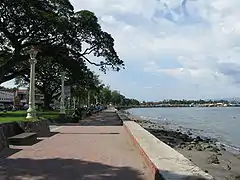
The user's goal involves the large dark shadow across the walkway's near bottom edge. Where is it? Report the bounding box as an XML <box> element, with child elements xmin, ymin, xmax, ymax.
<box><xmin>0</xmin><ymin>158</ymin><xmax>146</xmax><ymax>180</ymax></box>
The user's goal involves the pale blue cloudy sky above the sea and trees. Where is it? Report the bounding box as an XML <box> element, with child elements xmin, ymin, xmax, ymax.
<box><xmin>1</xmin><ymin>0</ymin><xmax>240</xmax><ymax>101</ymax></box>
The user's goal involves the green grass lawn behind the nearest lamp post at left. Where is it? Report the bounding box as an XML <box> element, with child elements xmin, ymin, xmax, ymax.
<box><xmin>0</xmin><ymin>111</ymin><xmax>59</xmax><ymax>123</ymax></box>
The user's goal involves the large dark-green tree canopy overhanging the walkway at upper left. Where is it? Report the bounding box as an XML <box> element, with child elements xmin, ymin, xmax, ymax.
<box><xmin>0</xmin><ymin>0</ymin><xmax>124</xmax><ymax>83</ymax></box>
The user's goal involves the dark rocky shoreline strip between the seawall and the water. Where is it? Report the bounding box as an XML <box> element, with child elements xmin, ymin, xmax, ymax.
<box><xmin>123</xmin><ymin>111</ymin><xmax>240</xmax><ymax>180</ymax></box>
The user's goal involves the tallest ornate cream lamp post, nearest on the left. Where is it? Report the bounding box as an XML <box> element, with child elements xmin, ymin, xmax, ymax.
<box><xmin>26</xmin><ymin>48</ymin><xmax>38</xmax><ymax>119</ymax></box>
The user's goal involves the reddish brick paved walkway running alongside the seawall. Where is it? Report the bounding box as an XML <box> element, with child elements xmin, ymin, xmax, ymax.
<box><xmin>0</xmin><ymin>112</ymin><xmax>150</xmax><ymax>180</ymax></box>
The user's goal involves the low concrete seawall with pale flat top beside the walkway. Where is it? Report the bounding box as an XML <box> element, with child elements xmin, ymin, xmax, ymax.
<box><xmin>118</xmin><ymin>112</ymin><xmax>214</xmax><ymax>180</ymax></box>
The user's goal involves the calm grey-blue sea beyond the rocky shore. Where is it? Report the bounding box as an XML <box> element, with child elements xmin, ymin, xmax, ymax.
<box><xmin>128</xmin><ymin>107</ymin><xmax>240</xmax><ymax>151</ymax></box>
